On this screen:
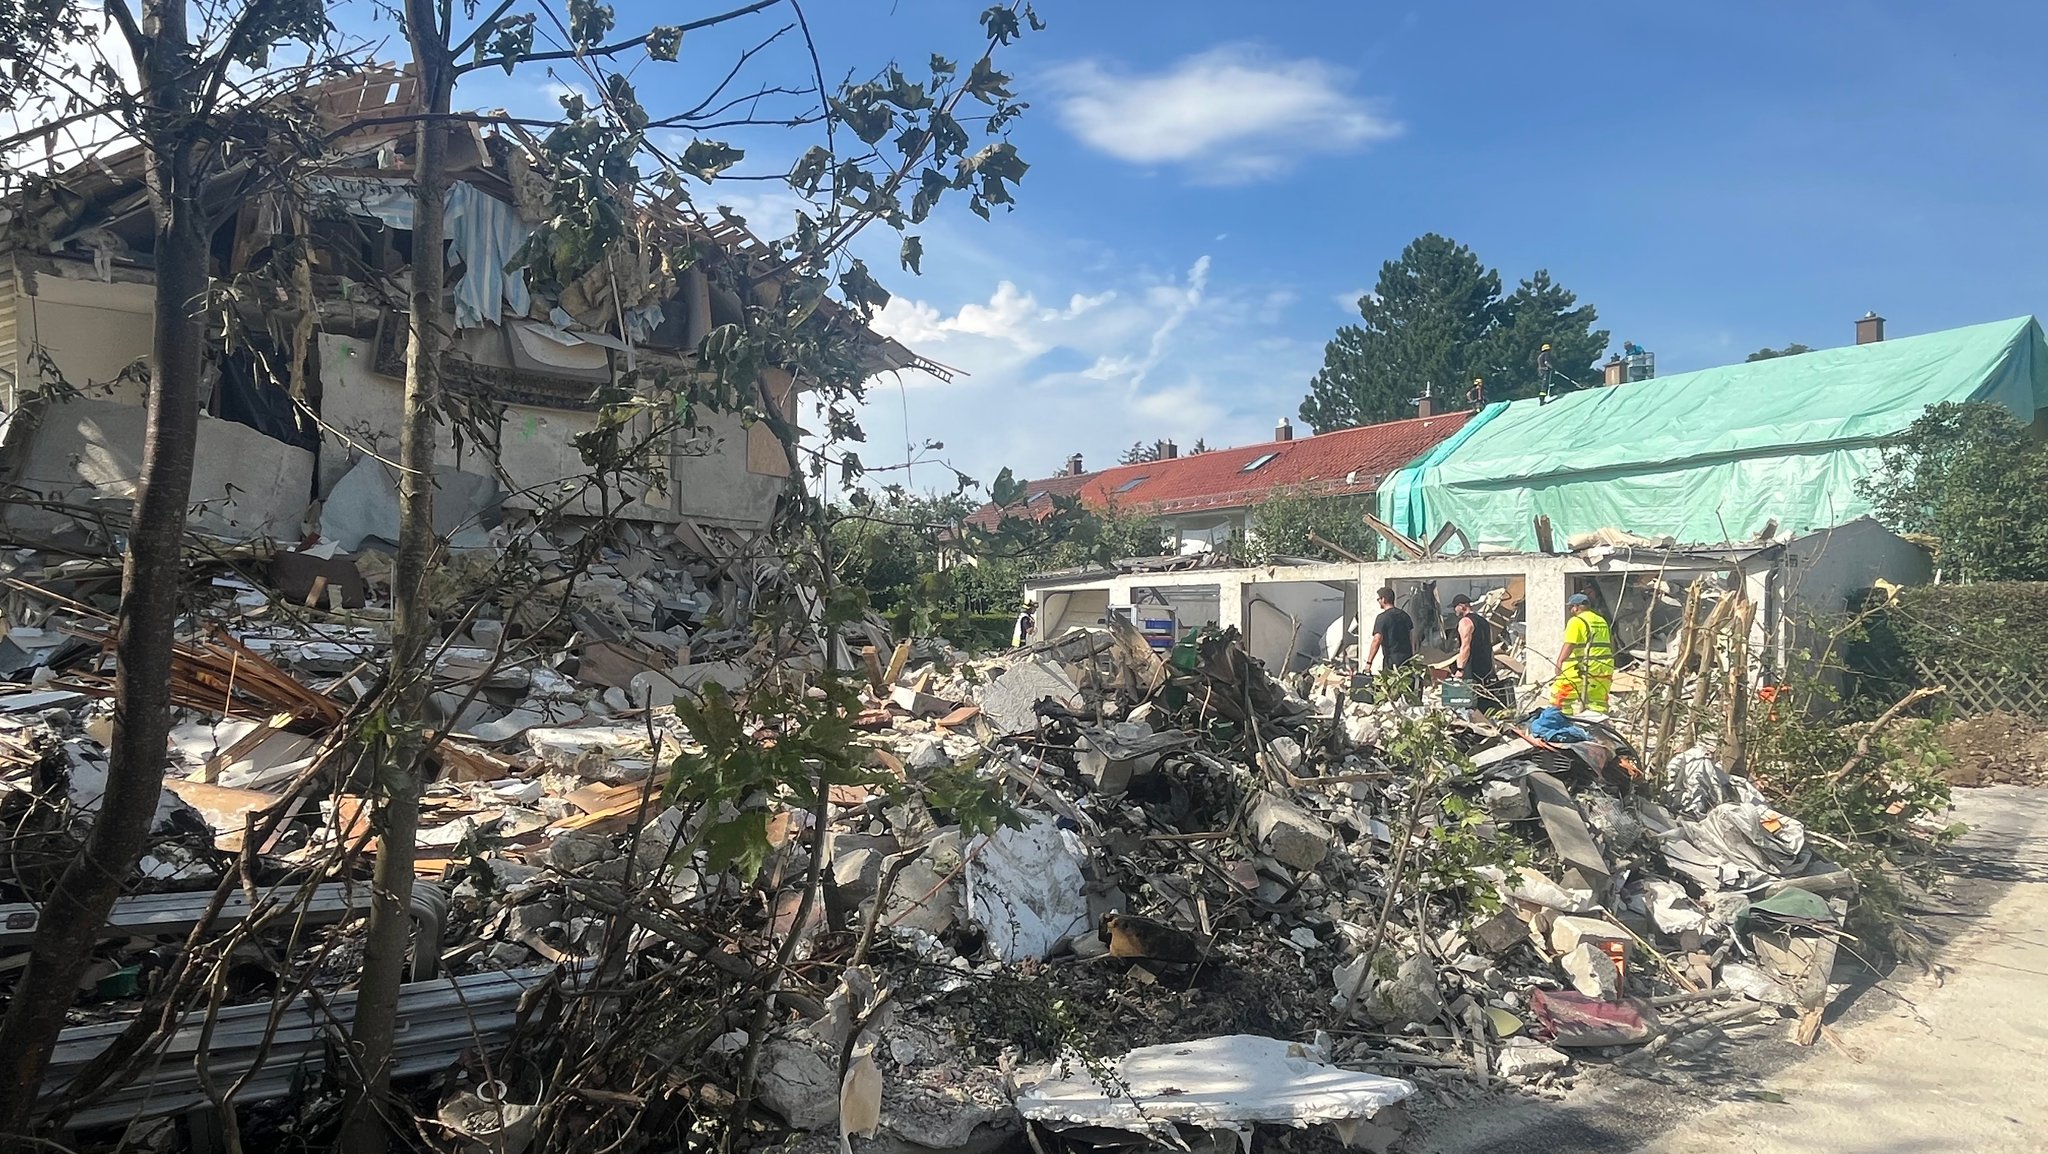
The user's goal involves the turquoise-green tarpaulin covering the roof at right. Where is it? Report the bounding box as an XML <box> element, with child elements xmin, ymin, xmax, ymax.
<box><xmin>1378</xmin><ymin>318</ymin><xmax>2048</xmax><ymax>549</ymax></box>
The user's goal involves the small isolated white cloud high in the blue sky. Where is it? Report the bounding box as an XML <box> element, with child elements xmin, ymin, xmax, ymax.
<box><xmin>1051</xmin><ymin>45</ymin><xmax>1401</xmax><ymax>182</ymax></box>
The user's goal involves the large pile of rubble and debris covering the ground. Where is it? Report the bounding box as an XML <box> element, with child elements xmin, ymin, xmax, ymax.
<box><xmin>0</xmin><ymin>539</ymin><xmax>1884</xmax><ymax>1150</ymax></box>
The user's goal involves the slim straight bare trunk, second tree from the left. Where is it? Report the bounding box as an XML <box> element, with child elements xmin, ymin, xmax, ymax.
<box><xmin>342</xmin><ymin>20</ymin><xmax>453</xmax><ymax>1154</ymax></box>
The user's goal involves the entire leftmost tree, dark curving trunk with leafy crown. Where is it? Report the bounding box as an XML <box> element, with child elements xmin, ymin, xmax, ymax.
<box><xmin>0</xmin><ymin>0</ymin><xmax>350</xmax><ymax>1148</ymax></box>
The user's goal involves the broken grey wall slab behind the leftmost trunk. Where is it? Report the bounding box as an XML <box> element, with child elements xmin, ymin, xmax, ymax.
<box><xmin>0</xmin><ymin>398</ymin><xmax>313</xmax><ymax>541</ymax></box>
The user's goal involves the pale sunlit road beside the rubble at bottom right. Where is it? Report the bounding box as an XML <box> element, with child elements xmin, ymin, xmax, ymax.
<box><xmin>1407</xmin><ymin>785</ymin><xmax>2048</xmax><ymax>1154</ymax></box>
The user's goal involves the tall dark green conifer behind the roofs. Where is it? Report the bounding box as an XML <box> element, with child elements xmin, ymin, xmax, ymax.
<box><xmin>1300</xmin><ymin>232</ymin><xmax>1608</xmax><ymax>432</ymax></box>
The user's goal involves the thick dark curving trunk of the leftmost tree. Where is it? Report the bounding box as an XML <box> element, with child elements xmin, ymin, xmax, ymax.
<box><xmin>0</xmin><ymin>9</ymin><xmax>209</xmax><ymax>1150</ymax></box>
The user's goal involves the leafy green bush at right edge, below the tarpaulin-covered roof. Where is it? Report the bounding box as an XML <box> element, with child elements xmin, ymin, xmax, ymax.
<box><xmin>1858</xmin><ymin>404</ymin><xmax>2048</xmax><ymax>580</ymax></box>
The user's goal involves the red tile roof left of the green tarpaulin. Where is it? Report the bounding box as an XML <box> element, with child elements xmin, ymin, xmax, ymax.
<box><xmin>969</xmin><ymin>412</ymin><xmax>1470</xmax><ymax>529</ymax></box>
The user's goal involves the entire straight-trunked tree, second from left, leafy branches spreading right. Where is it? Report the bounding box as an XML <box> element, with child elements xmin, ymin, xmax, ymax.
<box><xmin>342</xmin><ymin>0</ymin><xmax>1042</xmax><ymax>1154</ymax></box>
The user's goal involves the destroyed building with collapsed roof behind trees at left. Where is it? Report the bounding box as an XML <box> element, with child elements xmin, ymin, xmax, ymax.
<box><xmin>0</xmin><ymin>72</ymin><xmax>932</xmax><ymax>551</ymax></box>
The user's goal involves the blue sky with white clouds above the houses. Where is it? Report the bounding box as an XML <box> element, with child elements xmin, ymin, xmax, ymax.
<box><xmin>461</xmin><ymin>0</ymin><xmax>2048</xmax><ymax>486</ymax></box>
